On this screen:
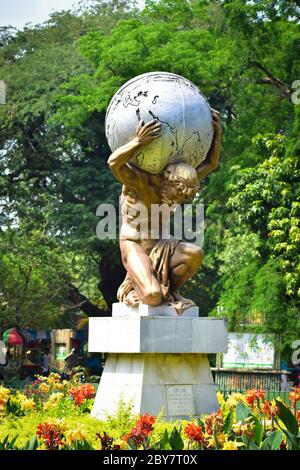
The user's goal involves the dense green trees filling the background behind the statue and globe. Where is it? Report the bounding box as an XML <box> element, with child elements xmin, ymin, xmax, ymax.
<box><xmin>0</xmin><ymin>0</ymin><xmax>300</xmax><ymax>350</ymax></box>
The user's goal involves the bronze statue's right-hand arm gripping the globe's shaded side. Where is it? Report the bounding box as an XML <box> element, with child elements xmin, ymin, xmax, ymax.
<box><xmin>196</xmin><ymin>109</ymin><xmax>222</xmax><ymax>182</ymax></box>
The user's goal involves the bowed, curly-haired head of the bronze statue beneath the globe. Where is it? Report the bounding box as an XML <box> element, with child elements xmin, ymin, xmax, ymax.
<box><xmin>162</xmin><ymin>163</ymin><xmax>199</xmax><ymax>205</ymax></box>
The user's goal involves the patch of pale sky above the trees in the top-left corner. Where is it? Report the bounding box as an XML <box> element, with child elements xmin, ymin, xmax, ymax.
<box><xmin>0</xmin><ymin>0</ymin><xmax>82</xmax><ymax>29</ymax></box>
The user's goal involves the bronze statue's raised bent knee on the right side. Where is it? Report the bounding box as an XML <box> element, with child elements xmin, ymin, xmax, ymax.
<box><xmin>170</xmin><ymin>242</ymin><xmax>203</xmax><ymax>290</ymax></box>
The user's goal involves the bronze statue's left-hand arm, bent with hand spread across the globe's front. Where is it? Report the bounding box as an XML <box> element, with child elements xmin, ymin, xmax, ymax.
<box><xmin>107</xmin><ymin>119</ymin><xmax>160</xmax><ymax>184</ymax></box>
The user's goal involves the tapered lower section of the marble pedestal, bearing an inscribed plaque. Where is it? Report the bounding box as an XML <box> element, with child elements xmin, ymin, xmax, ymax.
<box><xmin>91</xmin><ymin>354</ymin><xmax>218</xmax><ymax>420</ymax></box>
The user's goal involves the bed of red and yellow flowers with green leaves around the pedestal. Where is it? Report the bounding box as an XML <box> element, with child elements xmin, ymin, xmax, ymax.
<box><xmin>0</xmin><ymin>374</ymin><xmax>300</xmax><ymax>450</ymax></box>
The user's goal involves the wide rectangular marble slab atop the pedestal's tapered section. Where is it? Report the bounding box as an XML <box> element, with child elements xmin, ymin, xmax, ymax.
<box><xmin>89</xmin><ymin>317</ymin><xmax>227</xmax><ymax>354</ymax></box>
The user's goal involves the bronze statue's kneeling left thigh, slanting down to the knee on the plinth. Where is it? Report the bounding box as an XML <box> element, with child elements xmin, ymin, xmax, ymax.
<box><xmin>120</xmin><ymin>240</ymin><xmax>162</xmax><ymax>306</ymax></box>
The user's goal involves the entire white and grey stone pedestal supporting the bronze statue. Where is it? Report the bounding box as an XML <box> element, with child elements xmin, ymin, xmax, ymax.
<box><xmin>89</xmin><ymin>304</ymin><xmax>227</xmax><ymax>420</ymax></box>
